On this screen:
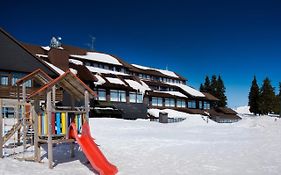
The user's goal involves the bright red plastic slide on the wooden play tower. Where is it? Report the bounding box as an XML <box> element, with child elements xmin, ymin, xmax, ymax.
<box><xmin>69</xmin><ymin>122</ymin><xmax>118</xmax><ymax>175</ymax></box>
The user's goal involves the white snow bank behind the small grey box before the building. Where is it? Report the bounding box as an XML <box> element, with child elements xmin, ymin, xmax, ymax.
<box><xmin>147</xmin><ymin>108</ymin><xmax>190</xmax><ymax>118</ymax></box>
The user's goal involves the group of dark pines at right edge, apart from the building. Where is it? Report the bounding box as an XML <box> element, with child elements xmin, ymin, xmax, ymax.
<box><xmin>248</xmin><ymin>76</ymin><xmax>281</xmax><ymax>115</ymax></box>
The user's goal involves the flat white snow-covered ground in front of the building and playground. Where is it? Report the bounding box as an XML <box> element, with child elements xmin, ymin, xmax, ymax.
<box><xmin>0</xmin><ymin>115</ymin><xmax>281</xmax><ymax>175</ymax></box>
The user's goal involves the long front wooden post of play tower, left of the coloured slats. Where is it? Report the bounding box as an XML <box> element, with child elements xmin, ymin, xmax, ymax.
<box><xmin>47</xmin><ymin>91</ymin><xmax>53</xmax><ymax>169</ymax></box>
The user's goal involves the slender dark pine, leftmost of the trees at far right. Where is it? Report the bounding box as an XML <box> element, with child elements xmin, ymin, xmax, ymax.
<box><xmin>248</xmin><ymin>76</ymin><xmax>260</xmax><ymax>115</ymax></box>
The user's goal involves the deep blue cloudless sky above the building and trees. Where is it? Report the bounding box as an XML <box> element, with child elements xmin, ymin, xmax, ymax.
<box><xmin>0</xmin><ymin>0</ymin><xmax>281</xmax><ymax>108</ymax></box>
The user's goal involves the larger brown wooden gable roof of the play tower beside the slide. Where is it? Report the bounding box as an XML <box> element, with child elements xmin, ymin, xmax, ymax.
<box><xmin>28</xmin><ymin>70</ymin><xmax>96</xmax><ymax>100</ymax></box>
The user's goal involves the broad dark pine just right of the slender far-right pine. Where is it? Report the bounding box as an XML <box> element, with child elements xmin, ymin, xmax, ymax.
<box><xmin>259</xmin><ymin>78</ymin><xmax>275</xmax><ymax>114</ymax></box>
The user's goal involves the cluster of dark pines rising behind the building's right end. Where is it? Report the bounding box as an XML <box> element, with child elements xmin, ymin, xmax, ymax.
<box><xmin>200</xmin><ymin>75</ymin><xmax>227</xmax><ymax>107</ymax></box>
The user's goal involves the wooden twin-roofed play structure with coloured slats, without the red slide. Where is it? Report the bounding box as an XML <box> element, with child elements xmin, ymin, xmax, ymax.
<box><xmin>0</xmin><ymin>69</ymin><xmax>95</xmax><ymax>168</ymax></box>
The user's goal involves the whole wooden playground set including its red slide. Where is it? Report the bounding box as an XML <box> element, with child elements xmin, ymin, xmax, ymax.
<box><xmin>0</xmin><ymin>69</ymin><xmax>118</xmax><ymax>175</ymax></box>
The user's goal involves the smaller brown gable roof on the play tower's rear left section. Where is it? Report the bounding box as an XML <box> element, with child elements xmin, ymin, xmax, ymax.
<box><xmin>16</xmin><ymin>69</ymin><xmax>53</xmax><ymax>85</ymax></box>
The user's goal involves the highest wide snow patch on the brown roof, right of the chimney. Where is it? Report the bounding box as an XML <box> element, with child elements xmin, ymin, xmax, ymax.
<box><xmin>70</xmin><ymin>52</ymin><xmax>122</xmax><ymax>66</ymax></box>
